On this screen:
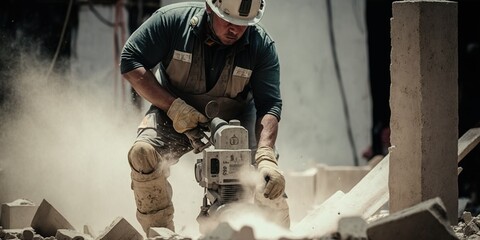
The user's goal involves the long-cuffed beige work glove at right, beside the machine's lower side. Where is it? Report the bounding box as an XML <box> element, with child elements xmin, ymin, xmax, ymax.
<box><xmin>255</xmin><ymin>146</ymin><xmax>285</xmax><ymax>200</ymax></box>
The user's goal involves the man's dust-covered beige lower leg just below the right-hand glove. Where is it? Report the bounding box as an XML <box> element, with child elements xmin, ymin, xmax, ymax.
<box><xmin>254</xmin><ymin>192</ymin><xmax>290</xmax><ymax>229</ymax></box>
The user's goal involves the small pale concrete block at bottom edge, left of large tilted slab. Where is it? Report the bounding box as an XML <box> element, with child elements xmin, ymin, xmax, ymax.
<box><xmin>337</xmin><ymin>217</ymin><xmax>367</xmax><ymax>240</ymax></box>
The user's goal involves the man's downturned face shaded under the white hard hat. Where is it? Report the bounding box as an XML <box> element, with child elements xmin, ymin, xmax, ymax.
<box><xmin>211</xmin><ymin>13</ymin><xmax>247</xmax><ymax>45</ymax></box>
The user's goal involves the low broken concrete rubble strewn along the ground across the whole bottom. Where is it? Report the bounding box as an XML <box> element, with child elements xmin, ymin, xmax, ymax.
<box><xmin>0</xmin><ymin>195</ymin><xmax>480</xmax><ymax>240</ymax></box>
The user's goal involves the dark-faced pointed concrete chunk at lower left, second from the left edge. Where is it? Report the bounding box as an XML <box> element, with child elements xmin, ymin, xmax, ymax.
<box><xmin>31</xmin><ymin>199</ymin><xmax>75</xmax><ymax>237</ymax></box>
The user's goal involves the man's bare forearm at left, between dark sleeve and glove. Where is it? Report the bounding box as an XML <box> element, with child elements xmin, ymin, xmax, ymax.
<box><xmin>122</xmin><ymin>67</ymin><xmax>175</xmax><ymax>111</ymax></box>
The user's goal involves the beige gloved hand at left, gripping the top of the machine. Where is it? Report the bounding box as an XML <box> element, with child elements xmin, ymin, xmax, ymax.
<box><xmin>167</xmin><ymin>98</ymin><xmax>208</xmax><ymax>133</ymax></box>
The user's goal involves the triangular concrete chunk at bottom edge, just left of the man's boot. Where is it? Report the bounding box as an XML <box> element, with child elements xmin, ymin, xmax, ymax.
<box><xmin>97</xmin><ymin>217</ymin><xmax>143</xmax><ymax>240</ymax></box>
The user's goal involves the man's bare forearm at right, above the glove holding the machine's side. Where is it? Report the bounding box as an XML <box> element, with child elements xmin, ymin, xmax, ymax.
<box><xmin>255</xmin><ymin>114</ymin><xmax>278</xmax><ymax>148</ymax></box>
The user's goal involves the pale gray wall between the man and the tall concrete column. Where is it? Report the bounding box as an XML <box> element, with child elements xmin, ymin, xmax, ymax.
<box><xmin>146</xmin><ymin>0</ymin><xmax>371</xmax><ymax>170</ymax></box>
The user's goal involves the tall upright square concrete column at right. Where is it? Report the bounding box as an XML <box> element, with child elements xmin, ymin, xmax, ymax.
<box><xmin>390</xmin><ymin>1</ymin><xmax>458</xmax><ymax>223</ymax></box>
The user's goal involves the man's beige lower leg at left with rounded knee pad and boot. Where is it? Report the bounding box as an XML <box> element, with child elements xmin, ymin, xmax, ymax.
<box><xmin>128</xmin><ymin>142</ymin><xmax>175</xmax><ymax>234</ymax></box>
